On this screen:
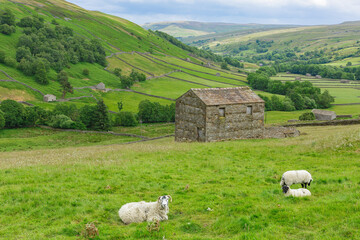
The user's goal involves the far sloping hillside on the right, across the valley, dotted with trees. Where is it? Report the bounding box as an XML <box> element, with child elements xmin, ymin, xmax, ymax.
<box><xmin>185</xmin><ymin>21</ymin><xmax>360</xmax><ymax>63</ymax></box>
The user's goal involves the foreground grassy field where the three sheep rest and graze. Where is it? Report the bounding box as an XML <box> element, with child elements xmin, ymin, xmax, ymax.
<box><xmin>0</xmin><ymin>125</ymin><xmax>360</xmax><ymax>239</ymax></box>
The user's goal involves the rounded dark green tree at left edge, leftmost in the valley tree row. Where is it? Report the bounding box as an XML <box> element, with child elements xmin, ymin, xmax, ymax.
<box><xmin>0</xmin><ymin>99</ymin><xmax>26</xmax><ymax>128</ymax></box>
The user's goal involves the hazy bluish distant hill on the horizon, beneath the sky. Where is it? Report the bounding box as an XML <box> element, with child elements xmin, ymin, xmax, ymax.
<box><xmin>143</xmin><ymin>21</ymin><xmax>300</xmax><ymax>38</ymax></box>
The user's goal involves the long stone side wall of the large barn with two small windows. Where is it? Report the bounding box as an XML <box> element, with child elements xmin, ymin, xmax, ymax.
<box><xmin>206</xmin><ymin>103</ymin><xmax>264</xmax><ymax>141</ymax></box>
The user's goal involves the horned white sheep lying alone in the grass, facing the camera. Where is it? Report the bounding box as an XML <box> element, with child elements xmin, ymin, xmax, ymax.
<box><xmin>119</xmin><ymin>195</ymin><xmax>172</xmax><ymax>224</ymax></box>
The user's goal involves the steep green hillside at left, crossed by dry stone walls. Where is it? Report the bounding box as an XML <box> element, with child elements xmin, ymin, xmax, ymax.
<box><xmin>0</xmin><ymin>0</ymin><xmax>246</xmax><ymax>112</ymax></box>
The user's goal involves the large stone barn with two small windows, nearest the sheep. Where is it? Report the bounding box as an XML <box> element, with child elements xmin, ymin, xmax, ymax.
<box><xmin>175</xmin><ymin>87</ymin><xmax>265</xmax><ymax>142</ymax></box>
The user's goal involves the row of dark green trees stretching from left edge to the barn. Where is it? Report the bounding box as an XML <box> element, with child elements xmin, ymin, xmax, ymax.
<box><xmin>0</xmin><ymin>100</ymin><xmax>175</xmax><ymax>130</ymax></box>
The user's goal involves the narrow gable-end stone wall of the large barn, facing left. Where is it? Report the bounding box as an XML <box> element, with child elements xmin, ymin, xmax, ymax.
<box><xmin>175</xmin><ymin>91</ymin><xmax>206</xmax><ymax>142</ymax></box>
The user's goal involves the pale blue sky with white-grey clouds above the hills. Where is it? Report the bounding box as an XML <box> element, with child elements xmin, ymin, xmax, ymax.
<box><xmin>68</xmin><ymin>0</ymin><xmax>360</xmax><ymax>25</ymax></box>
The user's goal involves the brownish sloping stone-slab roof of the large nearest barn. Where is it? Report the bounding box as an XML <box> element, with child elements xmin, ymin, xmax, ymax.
<box><xmin>190</xmin><ymin>87</ymin><xmax>264</xmax><ymax>105</ymax></box>
